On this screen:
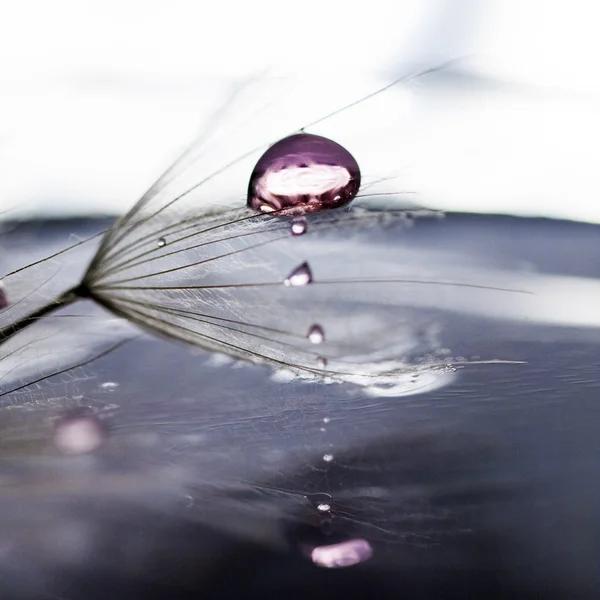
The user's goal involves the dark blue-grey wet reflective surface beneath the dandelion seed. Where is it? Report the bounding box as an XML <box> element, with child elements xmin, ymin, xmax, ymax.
<box><xmin>0</xmin><ymin>215</ymin><xmax>600</xmax><ymax>600</ymax></box>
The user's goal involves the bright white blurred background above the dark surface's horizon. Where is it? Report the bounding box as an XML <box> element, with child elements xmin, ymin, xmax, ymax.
<box><xmin>0</xmin><ymin>0</ymin><xmax>600</xmax><ymax>222</ymax></box>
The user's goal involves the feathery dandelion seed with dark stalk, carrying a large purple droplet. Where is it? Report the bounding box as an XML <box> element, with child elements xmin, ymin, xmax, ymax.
<box><xmin>0</xmin><ymin>65</ymin><xmax>518</xmax><ymax>393</ymax></box>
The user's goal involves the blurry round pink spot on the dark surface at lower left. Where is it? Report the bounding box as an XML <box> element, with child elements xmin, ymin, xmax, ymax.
<box><xmin>53</xmin><ymin>409</ymin><xmax>106</xmax><ymax>456</ymax></box>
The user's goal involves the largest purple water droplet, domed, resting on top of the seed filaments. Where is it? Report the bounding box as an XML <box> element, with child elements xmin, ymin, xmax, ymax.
<box><xmin>248</xmin><ymin>133</ymin><xmax>360</xmax><ymax>215</ymax></box>
